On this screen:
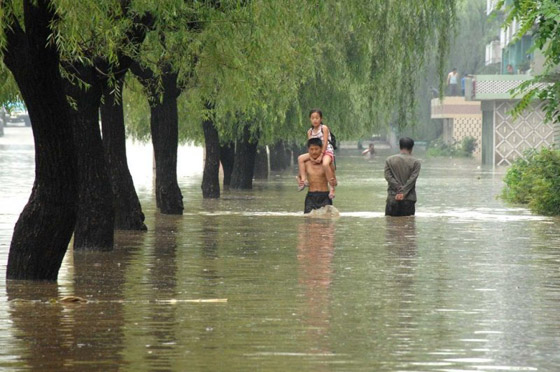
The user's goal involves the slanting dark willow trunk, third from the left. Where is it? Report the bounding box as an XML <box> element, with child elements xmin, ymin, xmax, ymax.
<box><xmin>101</xmin><ymin>79</ymin><xmax>147</xmax><ymax>230</ymax></box>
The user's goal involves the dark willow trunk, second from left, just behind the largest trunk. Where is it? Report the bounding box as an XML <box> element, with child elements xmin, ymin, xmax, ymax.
<box><xmin>66</xmin><ymin>65</ymin><xmax>114</xmax><ymax>251</ymax></box>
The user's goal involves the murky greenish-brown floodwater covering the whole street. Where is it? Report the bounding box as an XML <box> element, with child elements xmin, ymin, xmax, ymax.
<box><xmin>0</xmin><ymin>128</ymin><xmax>560</xmax><ymax>371</ymax></box>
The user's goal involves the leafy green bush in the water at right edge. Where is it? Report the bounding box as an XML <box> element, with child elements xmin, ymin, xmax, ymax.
<box><xmin>501</xmin><ymin>148</ymin><xmax>560</xmax><ymax>216</ymax></box>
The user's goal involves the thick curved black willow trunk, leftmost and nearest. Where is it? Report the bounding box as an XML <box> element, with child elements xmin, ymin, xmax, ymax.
<box><xmin>0</xmin><ymin>1</ymin><xmax>78</xmax><ymax>280</ymax></box>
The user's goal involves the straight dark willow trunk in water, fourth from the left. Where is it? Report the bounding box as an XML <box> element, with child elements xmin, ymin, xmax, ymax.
<box><xmin>150</xmin><ymin>73</ymin><xmax>183</xmax><ymax>214</ymax></box>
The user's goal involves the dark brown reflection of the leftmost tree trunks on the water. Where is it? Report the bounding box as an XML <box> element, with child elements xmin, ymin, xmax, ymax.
<box><xmin>6</xmin><ymin>232</ymin><xmax>144</xmax><ymax>371</ymax></box>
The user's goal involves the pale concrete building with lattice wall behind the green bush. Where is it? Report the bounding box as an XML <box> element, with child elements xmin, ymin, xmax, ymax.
<box><xmin>442</xmin><ymin>0</ymin><xmax>560</xmax><ymax>165</ymax></box>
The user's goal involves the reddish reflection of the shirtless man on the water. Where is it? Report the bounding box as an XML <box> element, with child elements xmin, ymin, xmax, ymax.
<box><xmin>297</xmin><ymin>218</ymin><xmax>335</xmax><ymax>360</ymax></box>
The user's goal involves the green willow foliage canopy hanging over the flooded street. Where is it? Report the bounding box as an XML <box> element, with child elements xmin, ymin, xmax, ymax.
<box><xmin>0</xmin><ymin>0</ymin><xmax>456</xmax><ymax>143</ymax></box>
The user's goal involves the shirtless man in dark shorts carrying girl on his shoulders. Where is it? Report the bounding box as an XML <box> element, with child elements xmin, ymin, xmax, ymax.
<box><xmin>297</xmin><ymin>138</ymin><xmax>332</xmax><ymax>213</ymax></box>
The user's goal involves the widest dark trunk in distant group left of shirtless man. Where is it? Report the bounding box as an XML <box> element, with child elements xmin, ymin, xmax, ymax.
<box><xmin>230</xmin><ymin>126</ymin><xmax>257</xmax><ymax>190</ymax></box>
